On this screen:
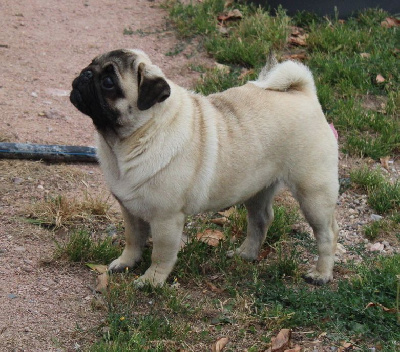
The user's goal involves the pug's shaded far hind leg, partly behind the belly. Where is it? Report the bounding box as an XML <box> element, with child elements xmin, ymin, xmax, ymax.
<box><xmin>228</xmin><ymin>182</ymin><xmax>279</xmax><ymax>260</ymax></box>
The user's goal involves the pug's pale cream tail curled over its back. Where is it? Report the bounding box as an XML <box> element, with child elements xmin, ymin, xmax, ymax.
<box><xmin>252</xmin><ymin>58</ymin><xmax>316</xmax><ymax>96</ymax></box>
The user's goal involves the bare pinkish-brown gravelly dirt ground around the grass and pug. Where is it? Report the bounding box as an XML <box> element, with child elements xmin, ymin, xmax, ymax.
<box><xmin>0</xmin><ymin>0</ymin><xmax>400</xmax><ymax>352</ymax></box>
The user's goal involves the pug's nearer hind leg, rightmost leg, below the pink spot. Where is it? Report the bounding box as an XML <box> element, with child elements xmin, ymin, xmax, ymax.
<box><xmin>298</xmin><ymin>186</ymin><xmax>339</xmax><ymax>285</ymax></box>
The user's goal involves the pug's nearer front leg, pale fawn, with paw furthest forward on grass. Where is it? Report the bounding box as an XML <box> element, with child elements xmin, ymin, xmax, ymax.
<box><xmin>135</xmin><ymin>213</ymin><xmax>185</xmax><ymax>287</ymax></box>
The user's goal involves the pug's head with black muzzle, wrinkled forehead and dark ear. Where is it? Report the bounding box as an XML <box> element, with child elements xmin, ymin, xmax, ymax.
<box><xmin>70</xmin><ymin>50</ymin><xmax>171</xmax><ymax>131</ymax></box>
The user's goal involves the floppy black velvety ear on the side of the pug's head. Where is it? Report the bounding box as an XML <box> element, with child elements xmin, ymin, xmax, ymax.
<box><xmin>137</xmin><ymin>63</ymin><xmax>171</xmax><ymax>111</ymax></box>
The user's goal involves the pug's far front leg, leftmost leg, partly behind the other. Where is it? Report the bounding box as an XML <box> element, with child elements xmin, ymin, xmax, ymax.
<box><xmin>108</xmin><ymin>204</ymin><xmax>150</xmax><ymax>272</ymax></box>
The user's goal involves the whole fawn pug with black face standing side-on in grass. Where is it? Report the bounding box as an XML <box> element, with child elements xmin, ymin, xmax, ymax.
<box><xmin>70</xmin><ymin>50</ymin><xmax>339</xmax><ymax>286</ymax></box>
